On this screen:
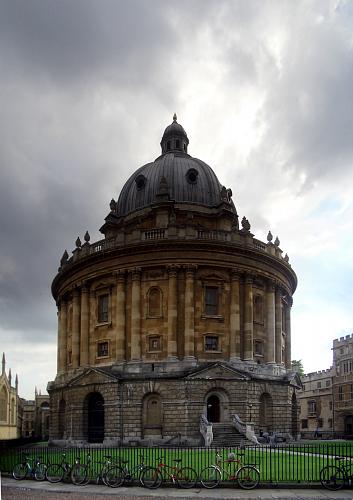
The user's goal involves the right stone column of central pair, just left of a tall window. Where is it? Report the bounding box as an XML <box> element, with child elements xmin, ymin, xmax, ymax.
<box><xmin>184</xmin><ymin>264</ymin><xmax>196</xmax><ymax>359</ymax></box>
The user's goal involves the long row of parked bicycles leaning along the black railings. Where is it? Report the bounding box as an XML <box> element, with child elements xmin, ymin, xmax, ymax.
<box><xmin>12</xmin><ymin>452</ymin><xmax>260</xmax><ymax>489</ymax></box>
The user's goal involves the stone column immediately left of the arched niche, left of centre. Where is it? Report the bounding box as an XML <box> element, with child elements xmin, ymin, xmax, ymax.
<box><xmin>131</xmin><ymin>267</ymin><xmax>141</xmax><ymax>361</ymax></box>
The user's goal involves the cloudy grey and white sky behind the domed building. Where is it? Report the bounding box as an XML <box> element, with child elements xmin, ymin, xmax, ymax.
<box><xmin>0</xmin><ymin>0</ymin><xmax>353</xmax><ymax>398</ymax></box>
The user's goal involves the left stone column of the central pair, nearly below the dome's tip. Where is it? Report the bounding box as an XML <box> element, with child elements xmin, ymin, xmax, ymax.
<box><xmin>167</xmin><ymin>265</ymin><xmax>178</xmax><ymax>361</ymax></box>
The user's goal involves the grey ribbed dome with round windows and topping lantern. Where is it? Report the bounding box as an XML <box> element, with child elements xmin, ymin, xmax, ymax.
<box><xmin>117</xmin><ymin>115</ymin><xmax>236</xmax><ymax>216</ymax></box>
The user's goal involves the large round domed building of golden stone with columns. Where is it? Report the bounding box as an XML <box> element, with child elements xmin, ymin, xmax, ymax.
<box><xmin>48</xmin><ymin>115</ymin><xmax>298</xmax><ymax>444</ymax></box>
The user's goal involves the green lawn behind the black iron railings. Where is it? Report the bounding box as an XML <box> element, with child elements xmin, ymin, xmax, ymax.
<box><xmin>0</xmin><ymin>441</ymin><xmax>353</xmax><ymax>483</ymax></box>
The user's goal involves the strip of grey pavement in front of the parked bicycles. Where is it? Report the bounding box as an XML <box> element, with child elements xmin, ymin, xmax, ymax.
<box><xmin>0</xmin><ymin>477</ymin><xmax>353</xmax><ymax>500</ymax></box>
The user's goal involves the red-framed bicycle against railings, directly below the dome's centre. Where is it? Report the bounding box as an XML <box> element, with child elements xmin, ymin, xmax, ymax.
<box><xmin>141</xmin><ymin>457</ymin><xmax>198</xmax><ymax>489</ymax></box>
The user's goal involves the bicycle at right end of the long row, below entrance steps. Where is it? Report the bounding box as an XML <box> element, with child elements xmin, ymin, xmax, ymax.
<box><xmin>200</xmin><ymin>451</ymin><xmax>260</xmax><ymax>490</ymax></box>
